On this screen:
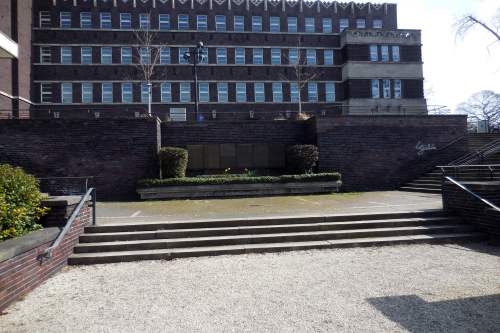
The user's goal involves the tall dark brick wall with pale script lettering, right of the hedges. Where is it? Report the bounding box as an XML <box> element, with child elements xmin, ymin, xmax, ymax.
<box><xmin>316</xmin><ymin>116</ymin><xmax>467</xmax><ymax>191</ymax></box>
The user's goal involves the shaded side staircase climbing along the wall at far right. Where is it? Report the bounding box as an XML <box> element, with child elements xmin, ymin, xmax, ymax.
<box><xmin>400</xmin><ymin>133</ymin><xmax>500</xmax><ymax>194</ymax></box>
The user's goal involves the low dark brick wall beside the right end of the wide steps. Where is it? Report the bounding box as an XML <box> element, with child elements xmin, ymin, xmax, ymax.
<box><xmin>443</xmin><ymin>181</ymin><xmax>500</xmax><ymax>241</ymax></box>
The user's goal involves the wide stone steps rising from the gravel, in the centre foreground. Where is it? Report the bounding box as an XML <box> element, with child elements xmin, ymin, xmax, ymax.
<box><xmin>69</xmin><ymin>210</ymin><xmax>484</xmax><ymax>265</ymax></box>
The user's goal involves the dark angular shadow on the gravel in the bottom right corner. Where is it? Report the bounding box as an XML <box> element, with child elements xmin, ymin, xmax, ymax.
<box><xmin>367</xmin><ymin>294</ymin><xmax>500</xmax><ymax>332</ymax></box>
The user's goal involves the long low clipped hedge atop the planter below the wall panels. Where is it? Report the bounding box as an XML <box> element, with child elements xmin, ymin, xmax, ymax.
<box><xmin>138</xmin><ymin>172</ymin><xmax>341</xmax><ymax>187</ymax></box>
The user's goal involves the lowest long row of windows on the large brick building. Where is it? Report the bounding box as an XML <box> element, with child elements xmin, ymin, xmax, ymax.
<box><xmin>40</xmin><ymin>82</ymin><xmax>335</xmax><ymax>104</ymax></box>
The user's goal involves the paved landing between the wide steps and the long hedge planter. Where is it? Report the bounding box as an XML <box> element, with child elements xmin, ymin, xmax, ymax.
<box><xmin>97</xmin><ymin>191</ymin><xmax>442</xmax><ymax>224</ymax></box>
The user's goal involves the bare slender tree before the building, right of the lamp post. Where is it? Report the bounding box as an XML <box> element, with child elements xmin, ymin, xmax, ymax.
<box><xmin>282</xmin><ymin>37</ymin><xmax>321</xmax><ymax>117</ymax></box>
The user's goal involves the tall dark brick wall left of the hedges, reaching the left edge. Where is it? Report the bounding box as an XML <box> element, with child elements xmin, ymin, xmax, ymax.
<box><xmin>0</xmin><ymin>119</ymin><xmax>160</xmax><ymax>200</ymax></box>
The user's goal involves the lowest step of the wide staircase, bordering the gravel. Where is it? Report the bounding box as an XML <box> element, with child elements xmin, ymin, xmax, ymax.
<box><xmin>68</xmin><ymin>232</ymin><xmax>485</xmax><ymax>265</ymax></box>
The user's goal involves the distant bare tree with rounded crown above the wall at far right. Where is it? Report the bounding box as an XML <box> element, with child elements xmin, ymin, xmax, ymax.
<box><xmin>457</xmin><ymin>90</ymin><xmax>500</xmax><ymax>127</ymax></box>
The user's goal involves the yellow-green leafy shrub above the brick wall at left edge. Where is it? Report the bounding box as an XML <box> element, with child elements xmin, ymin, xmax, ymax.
<box><xmin>0</xmin><ymin>164</ymin><xmax>48</xmax><ymax>241</ymax></box>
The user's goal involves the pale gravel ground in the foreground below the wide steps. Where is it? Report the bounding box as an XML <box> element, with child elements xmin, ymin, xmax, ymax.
<box><xmin>0</xmin><ymin>244</ymin><xmax>500</xmax><ymax>332</ymax></box>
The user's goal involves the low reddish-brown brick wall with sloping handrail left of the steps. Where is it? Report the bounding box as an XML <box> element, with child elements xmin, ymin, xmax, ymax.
<box><xmin>0</xmin><ymin>198</ymin><xmax>92</xmax><ymax>311</ymax></box>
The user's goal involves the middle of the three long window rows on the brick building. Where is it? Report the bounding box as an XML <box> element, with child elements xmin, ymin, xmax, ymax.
<box><xmin>40</xmin><ymin>46</ymin><xmax>335</xmax><ymax>65</ymax></box>
